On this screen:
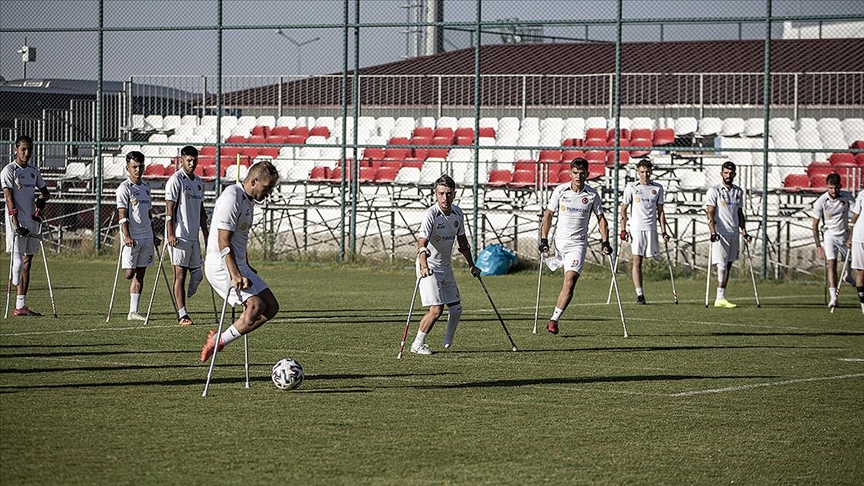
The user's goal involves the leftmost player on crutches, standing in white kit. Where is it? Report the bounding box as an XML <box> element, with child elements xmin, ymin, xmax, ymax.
<box><xmin>0</xmin><ymin>135</ymin><xmax>56</xmax><ymax>317</ymax></box>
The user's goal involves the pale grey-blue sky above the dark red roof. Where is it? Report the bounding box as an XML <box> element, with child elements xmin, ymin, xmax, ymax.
<box><xmin>0</xmin><ymin>0</ymin><xmax>864</xmax><ymax>81</ymax></box>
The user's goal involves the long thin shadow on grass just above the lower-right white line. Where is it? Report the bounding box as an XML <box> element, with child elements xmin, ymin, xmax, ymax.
<box><xmin>406</xmin><ymin>375</ymin><xmax>777</xmax><ymax>389</ymax></box>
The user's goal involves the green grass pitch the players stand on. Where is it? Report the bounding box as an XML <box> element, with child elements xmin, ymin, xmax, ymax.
<box><xmin>0</xmin><ymin>257</ymin><xmax>864</xmax><ymax>485</ymax></box>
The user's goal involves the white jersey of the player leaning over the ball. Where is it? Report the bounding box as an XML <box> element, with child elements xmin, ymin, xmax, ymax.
<box><xmin>207</xmin><ymin>182</ymin><xmax>255</xmax><ymax>265</ymax></box>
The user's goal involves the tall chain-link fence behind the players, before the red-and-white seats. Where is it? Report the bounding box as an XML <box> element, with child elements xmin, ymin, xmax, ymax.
<box><xmin>0</xmin><ymin>0</ymin><xmax>864</xmax><ymax>278</ymax></box>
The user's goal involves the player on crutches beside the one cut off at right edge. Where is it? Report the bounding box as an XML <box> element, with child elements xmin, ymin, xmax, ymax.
<box><xmin>812</xmin><ymin>173</ymin><xmax>854</xmax><ymax>309</ymax></box>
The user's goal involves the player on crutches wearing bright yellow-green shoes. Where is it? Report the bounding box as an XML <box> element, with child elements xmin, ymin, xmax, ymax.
<box><xmin>705</xmin><ymin>161</ymin><xmax>753</xmax><ymax>309</ymax></box>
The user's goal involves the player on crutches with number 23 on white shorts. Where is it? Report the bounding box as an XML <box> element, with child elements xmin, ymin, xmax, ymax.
<box><xmin>537</xmin><ymin>157</ymin><xmax>612</xmax><ymax>334</ymax></box>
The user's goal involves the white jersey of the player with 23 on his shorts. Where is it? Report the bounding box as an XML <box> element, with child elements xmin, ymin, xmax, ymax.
<box><xmin>546</xmin><ymin>182</ymin><xmax>603</xmax><ymax>245</ymax></box>
